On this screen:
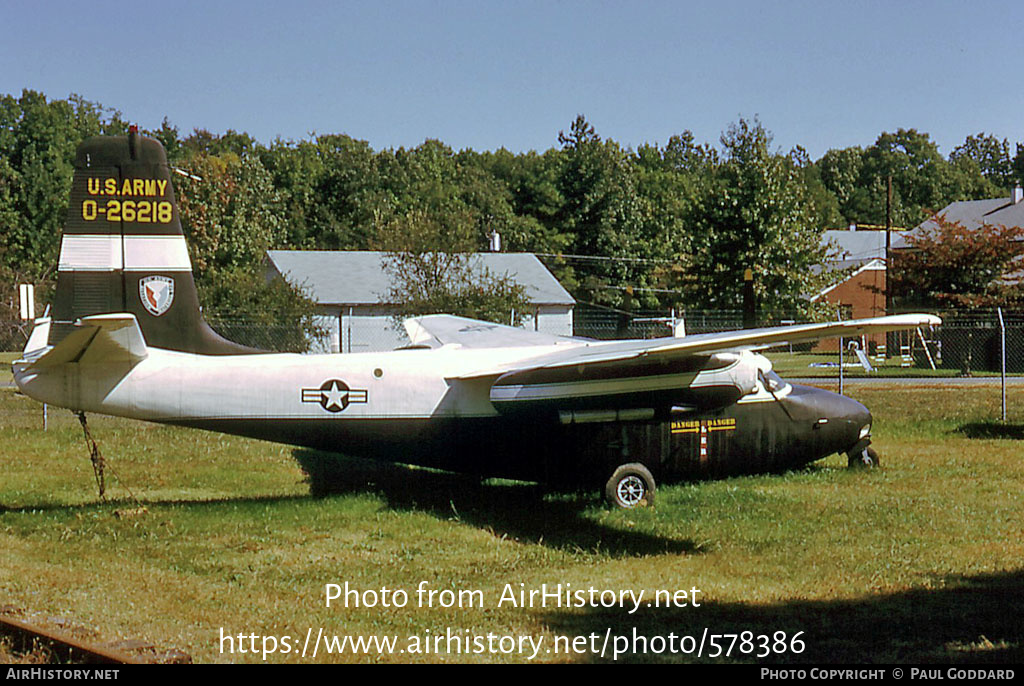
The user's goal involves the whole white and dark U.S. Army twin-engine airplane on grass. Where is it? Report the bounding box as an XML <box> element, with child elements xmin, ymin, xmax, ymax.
<box><xmin>13</xmin><ymin>131</ymin><xmax>939</xmax><ymax>507</ymax></box>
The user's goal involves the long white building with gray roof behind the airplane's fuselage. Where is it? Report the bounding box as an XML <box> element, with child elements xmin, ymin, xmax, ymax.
<box><xmin>266</xmin><ymin>250</ymin><xmax>575</xmax><ymax>352</ymax></box>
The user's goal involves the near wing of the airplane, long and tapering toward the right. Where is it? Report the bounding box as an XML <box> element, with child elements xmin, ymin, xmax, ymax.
<box><xmin>458</xmin><ymin>314</ymin><xmax>942</xmax><ymax>380</ymax></box>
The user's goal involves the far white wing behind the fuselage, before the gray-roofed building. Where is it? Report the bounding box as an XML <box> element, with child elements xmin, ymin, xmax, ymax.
<box><xmin>402</xmin><ymin>314</ymin><xmax>583</xmax><ymax>348</ymax></box>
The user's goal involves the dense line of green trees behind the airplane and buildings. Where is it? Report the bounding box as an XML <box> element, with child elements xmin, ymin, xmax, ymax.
<box><xmin>0</xmin><ymin>90</ymin><xmax>1024</xmax><ymax>341</ymax></box>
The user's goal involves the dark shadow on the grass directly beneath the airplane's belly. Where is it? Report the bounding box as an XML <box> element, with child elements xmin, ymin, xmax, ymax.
<box><xmin>293</xmin><ymin>449</ymin><xmax>701</xmax><ymax>557</ymax></box>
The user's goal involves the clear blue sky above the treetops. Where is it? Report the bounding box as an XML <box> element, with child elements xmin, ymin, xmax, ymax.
<box><xmin>0</xmin><ymin>0</ymin><xmax>1024</xmax><ymax>159</ymax></box>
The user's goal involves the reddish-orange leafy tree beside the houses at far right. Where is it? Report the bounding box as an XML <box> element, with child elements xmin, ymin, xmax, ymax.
<box><xmin>892</xmin><ymin>215</ymin><xmax>1024</xmax><ymax>307</ymax></box>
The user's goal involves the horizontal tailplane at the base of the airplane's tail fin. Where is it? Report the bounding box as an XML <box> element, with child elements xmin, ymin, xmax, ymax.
<box><xmin>24</xmin><ymin>313</ymin><xmax>148</xmax><ymax>369</ymax></box>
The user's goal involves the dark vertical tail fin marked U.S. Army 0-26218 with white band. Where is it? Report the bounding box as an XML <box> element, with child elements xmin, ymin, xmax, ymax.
<box><xmin>49</xmin><ymin>127</ymin><xmax>258</xmax><ymax>355</ymax></box>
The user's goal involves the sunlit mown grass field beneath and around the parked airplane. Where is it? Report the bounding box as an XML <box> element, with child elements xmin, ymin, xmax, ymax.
<box><xmin>0</xmin><ymin>368</ymin><xmax>1024</xmax><ymax>662</ymax></box>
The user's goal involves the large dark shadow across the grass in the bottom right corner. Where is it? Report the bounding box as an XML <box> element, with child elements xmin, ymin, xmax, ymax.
<box><xmin>543</xmin><ymin>570</ymin><xmax>1024</xmax><ymax>677</ymax></box>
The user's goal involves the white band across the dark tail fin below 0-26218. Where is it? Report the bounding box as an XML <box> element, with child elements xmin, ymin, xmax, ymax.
<box><xmin>57</xmin><ymin>233</ymin><xmax>191</xmax><ymax>271</ymax></box>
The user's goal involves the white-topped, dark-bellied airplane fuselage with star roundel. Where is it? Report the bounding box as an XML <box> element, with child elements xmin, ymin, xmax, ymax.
<box><xmin>15</xmin><ymin>345</ymin><xmax>870</xmax><ymax>482</ymax></box>
